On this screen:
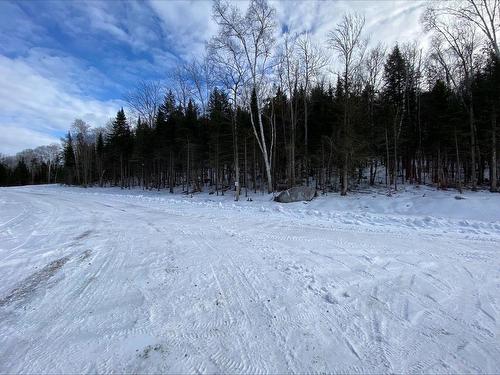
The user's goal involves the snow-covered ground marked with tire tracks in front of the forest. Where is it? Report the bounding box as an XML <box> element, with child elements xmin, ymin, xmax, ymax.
<box><xmin>0</xmin><ymin>186</ymin><xmax>500</xmax><ymax>373</ymax></box>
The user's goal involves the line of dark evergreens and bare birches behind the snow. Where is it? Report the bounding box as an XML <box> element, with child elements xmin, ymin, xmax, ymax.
<box><xmin>0</xmin><ymin>0</ymin><xmax>500</xmax><ymax>199</ymax></box>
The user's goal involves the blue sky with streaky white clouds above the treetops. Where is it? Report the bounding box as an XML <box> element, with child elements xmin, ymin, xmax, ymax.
<box><xmin>0</xmin><ymin>0</ymin><xmax>424</xmax><ymax>154</ymax></box>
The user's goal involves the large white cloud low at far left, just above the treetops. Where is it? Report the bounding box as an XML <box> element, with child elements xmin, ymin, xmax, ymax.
<box><xmin>0</xmin><ymin>55</ymin><xmax>123</xmax><ymax>153</ymax></box>
